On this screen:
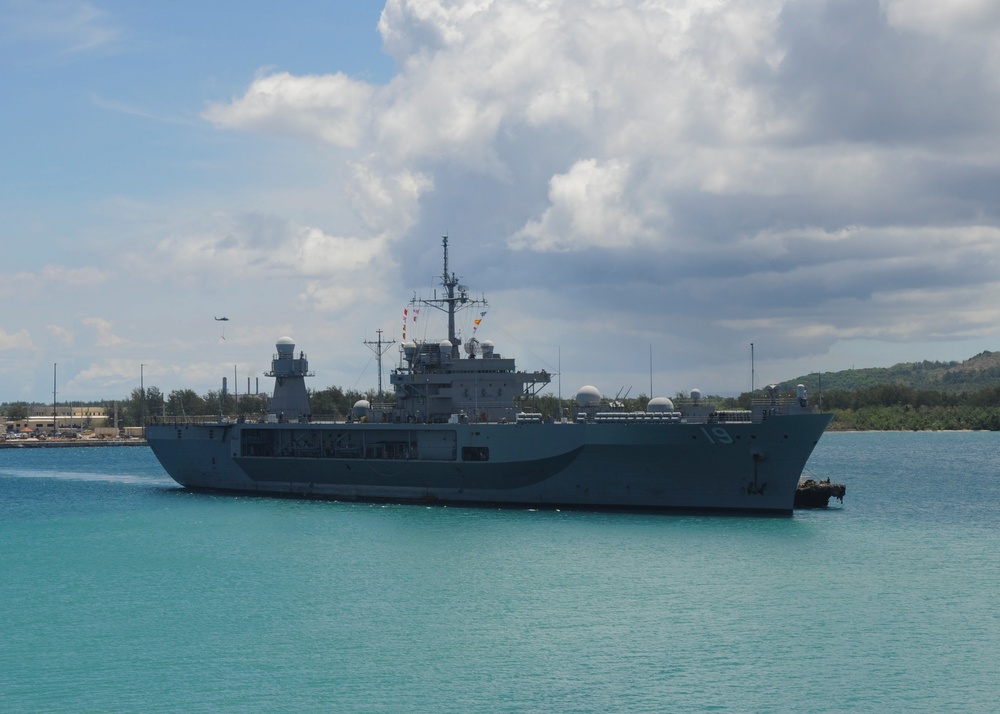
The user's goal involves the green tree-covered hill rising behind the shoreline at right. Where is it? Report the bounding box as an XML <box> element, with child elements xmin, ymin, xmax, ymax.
<box><xmin>779</xmin><ymin>351</ymin><xmax>1000</xmax><ymax>394</ymax></box>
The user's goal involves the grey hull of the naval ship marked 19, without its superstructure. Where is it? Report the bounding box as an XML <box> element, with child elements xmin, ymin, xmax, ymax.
<box><xmin>146</xmin><ymin>414</ymin><xmax>831</xmax><ymax>514</ymax></box>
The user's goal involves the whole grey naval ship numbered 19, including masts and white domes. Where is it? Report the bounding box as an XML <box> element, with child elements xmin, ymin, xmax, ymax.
<box><xmin>146</xmin><ymin>238</ymin><xmax>832</xmax><ymax>514</ymax></box>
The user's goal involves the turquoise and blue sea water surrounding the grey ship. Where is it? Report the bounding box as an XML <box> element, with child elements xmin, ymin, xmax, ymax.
<box><xmin>0</xmin><ymin>433</ymin><xmax>1000</xmax><ymax>712</ymax></box>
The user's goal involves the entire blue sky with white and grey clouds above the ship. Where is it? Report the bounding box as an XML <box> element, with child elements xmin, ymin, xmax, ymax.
<box><xmin>0</xmin><ymin>0</ymin><xmax>1000</xmax><ymax>402</ymax></box>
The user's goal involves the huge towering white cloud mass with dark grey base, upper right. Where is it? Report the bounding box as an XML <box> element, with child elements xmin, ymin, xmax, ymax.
<box><xmin>184</xmin><ymin>0</ymin><xmax>1000</xmax><ymax>390</ymax></box>
